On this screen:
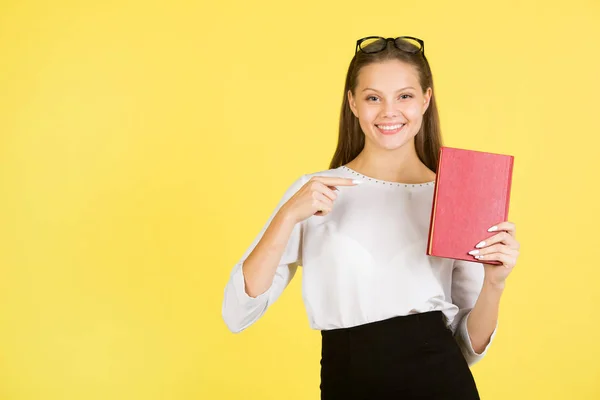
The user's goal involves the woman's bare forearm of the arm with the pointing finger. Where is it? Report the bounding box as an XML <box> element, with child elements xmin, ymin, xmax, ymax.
<box><xmin>242</xmin><ymin>210</ymin><xmax>296</xmax><ymax>297</ymax></box>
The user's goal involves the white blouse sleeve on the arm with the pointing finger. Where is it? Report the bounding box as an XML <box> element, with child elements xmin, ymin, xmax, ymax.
<box><xmin>221</xmin><ymin>175</ymin><xmax>308</xmax><ymax>333</ymax></box>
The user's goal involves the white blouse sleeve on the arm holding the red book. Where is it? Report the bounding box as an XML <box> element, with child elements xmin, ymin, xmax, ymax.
<box><xmin>451</xmin><ymin>260</ymin><xmax>498</xmax><ymax>366</ymax></box>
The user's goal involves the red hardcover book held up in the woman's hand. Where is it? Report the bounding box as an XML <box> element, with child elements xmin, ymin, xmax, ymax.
<box><xmin>427</xmin><ymin>147</ymin><xmax>514</xmax><ymax>264</ymax></box>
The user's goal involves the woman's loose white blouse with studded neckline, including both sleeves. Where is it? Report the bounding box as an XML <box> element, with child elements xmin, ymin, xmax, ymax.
<box><xmin>222</xmin><ymin>166</ymin><xmax>497</xmax><ymax>365</ymax></box>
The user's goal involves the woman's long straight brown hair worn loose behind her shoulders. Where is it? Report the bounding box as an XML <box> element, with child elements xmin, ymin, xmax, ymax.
<box><xmin>329</xmin><ymin>41</ymin><xmax>442</xmax><ymax>172</ymax></box>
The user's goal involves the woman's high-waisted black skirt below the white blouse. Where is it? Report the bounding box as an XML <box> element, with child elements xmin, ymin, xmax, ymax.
<box><xmin>320</xmin><ymin>311</ymin><xmax>479</xmax><ymax>400</ymax></box>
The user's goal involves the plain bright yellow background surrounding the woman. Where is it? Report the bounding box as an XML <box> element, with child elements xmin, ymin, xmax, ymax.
<box><xmin>0</xmin><ymin>0</ymin><xmax>600</xmax><ymax>400</ymax></box>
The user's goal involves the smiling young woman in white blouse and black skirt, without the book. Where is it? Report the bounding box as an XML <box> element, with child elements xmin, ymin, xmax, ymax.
<box><xmin>222</xmin><ymin>37</ymin><xmax>519</xmax><ymax>400</ymax></box>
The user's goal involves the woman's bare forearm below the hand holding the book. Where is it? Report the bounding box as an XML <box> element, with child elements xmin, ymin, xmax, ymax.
<box><xmin>467</xmin><ymin>281</ymin><xmax>504</xmax><ymax>353</ymax></box>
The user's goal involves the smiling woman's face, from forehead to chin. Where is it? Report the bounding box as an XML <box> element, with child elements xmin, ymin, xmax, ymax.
<box><xmin>348</xmin><ymin>60</ymin><xmax>432</xmax><ymax>150</ymax></box>
